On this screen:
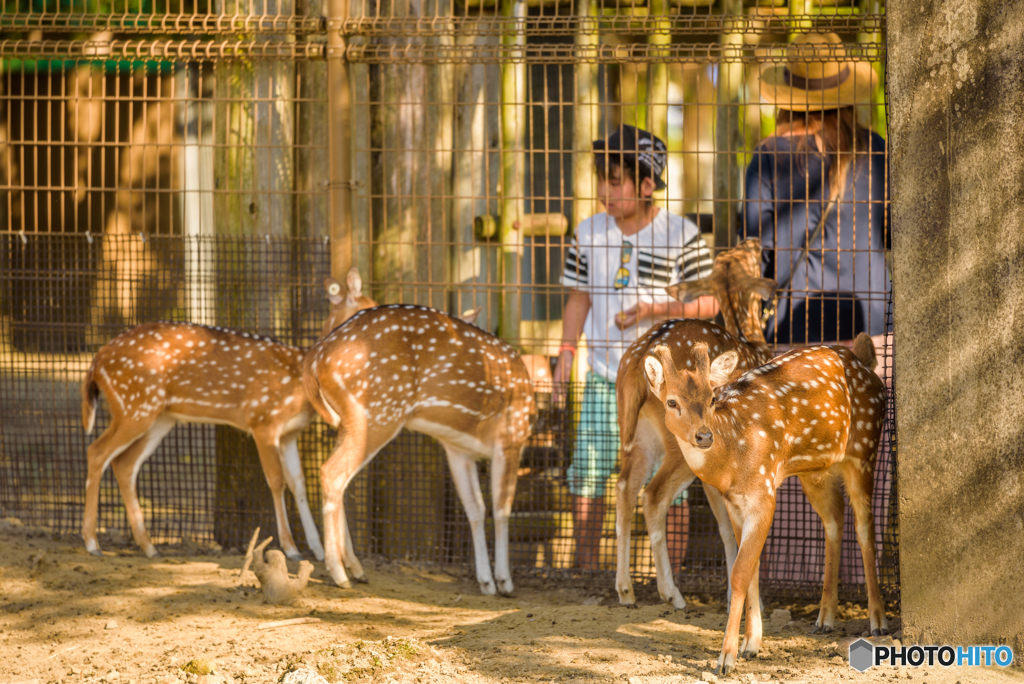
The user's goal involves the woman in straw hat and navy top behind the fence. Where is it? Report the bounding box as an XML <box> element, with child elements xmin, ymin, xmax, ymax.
<box><xmin>740</xmin><ymin>34</ymin><xmax>891</xmax><ymax>344</ymax></box>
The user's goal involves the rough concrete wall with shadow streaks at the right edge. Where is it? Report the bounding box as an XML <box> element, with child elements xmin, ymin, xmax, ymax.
<box><xmin>888</xmin><ymin>0</ymin><xmax>1024</xmax><ymax>661</ymax></box>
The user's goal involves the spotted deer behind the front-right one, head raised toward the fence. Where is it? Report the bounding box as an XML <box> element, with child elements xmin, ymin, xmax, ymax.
<box><xmin>615</xmin><ymin>240</ymin><xmax>775</xmax><ymax>608</ymax></box>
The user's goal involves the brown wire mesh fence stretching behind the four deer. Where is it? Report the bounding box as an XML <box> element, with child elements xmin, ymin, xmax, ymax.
<box><xmin>0</xmin><ymin>0</ymin><xmax>898</xmax><ymax>599</ymax></box>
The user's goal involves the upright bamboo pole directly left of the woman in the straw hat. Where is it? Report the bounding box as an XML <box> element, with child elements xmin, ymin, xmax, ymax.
<box><xmin>715</xmin><ymin>0</ymin><xmax>743</xmax><ymax>249</ymax></box>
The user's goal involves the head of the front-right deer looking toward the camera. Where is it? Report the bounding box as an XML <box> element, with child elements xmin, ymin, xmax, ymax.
<box><xmin>643</xmin><ymin>342</ymin><xmax>739</xmax><ymax>448</ymax></box>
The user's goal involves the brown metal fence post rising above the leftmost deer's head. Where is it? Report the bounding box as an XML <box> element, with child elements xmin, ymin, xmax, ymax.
<box><xmin>327</xmin><ymin>0</ymin><xmax>352</xmax><ymax>282</ymax></box>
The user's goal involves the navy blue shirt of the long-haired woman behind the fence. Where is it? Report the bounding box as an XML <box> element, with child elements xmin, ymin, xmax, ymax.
<box><xmin>739</xmin><ymin>132</ymin><xmax>892</xmax><ymax>344</ymax></box>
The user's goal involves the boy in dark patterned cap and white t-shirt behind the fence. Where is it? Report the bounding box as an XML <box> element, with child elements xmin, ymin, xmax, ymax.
<box><xmin>554</xmin><ymin>125</ymin><xmax>718</xmax><ymax>569</ymax></box>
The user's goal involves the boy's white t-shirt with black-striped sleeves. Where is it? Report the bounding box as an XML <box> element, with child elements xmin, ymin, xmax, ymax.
<box><xmin>561</xmin><ymin>209</ymin><xmax>713</xmax><ymax>383</ymax></box>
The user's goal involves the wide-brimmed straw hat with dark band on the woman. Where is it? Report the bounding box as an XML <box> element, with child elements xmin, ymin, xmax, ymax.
<box><xmin>761</xmin><ymin>33</ymin><xmax>878</xmax><ymax>112</ymax></box>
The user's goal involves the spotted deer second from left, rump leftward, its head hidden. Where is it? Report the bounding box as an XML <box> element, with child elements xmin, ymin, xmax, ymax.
<box><xmin>302</xmin><ymin>305</ymin><xmax>537</xmax><ymax>594</ymax></box>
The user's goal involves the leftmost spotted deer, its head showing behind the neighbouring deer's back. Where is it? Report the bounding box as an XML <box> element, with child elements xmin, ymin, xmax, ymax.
<box><xmin>82</xmin><ymin>268</ymin><xmax>376</xmax><ymax>560</ymax></box>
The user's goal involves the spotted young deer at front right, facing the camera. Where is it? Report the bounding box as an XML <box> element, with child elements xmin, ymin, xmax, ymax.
<box><xmin>644</xmin><ymin>333</ymin><xmax>888</xmax><ymax>674</ymax></box>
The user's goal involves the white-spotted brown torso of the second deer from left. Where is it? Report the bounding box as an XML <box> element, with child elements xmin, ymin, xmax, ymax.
<box><xmin>305</xmin><ymin>304</ymin><xmax>537</xmax><ymax>457</ymax></box>
